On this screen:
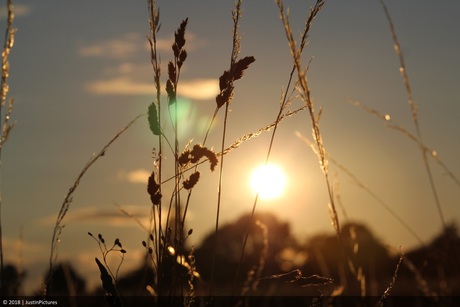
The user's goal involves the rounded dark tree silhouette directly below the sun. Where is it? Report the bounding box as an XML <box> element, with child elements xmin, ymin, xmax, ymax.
<box><xmin>195</xmin><ymin>213</ymin><xmax>297</xmax><ymax>296</ymax></box>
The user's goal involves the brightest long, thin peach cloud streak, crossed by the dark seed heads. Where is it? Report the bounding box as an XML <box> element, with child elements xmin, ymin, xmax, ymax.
<box><xmin>86</xmin><ymin>76</ymin><xmax>219</xmax><ymax>100</ymax></box>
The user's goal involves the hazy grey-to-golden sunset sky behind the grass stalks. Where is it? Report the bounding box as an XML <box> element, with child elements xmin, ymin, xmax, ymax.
<box><xmin>0</xmin><ymin>0</ymin><xmax>460</xmax><ymax>291</ymax></box>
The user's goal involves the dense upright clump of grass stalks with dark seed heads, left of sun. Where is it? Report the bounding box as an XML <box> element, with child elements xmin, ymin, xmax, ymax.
<box><xmin>144</xmin><ymin>1</ymin><xmax>226</xmax><ymax>297</ymax></box>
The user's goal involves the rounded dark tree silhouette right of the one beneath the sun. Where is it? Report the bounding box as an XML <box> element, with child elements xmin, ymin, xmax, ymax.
<box><xmin>304</xmin><ymin>223</ymin><xmax>397</xmax><ymax>295</ymax></box>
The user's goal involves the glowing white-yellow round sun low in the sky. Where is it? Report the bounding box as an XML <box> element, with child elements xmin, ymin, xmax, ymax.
<box><xmin>250</xmin><ymin>164</ymin><xmax>286</xmax><ymax>199</ymax></box>
